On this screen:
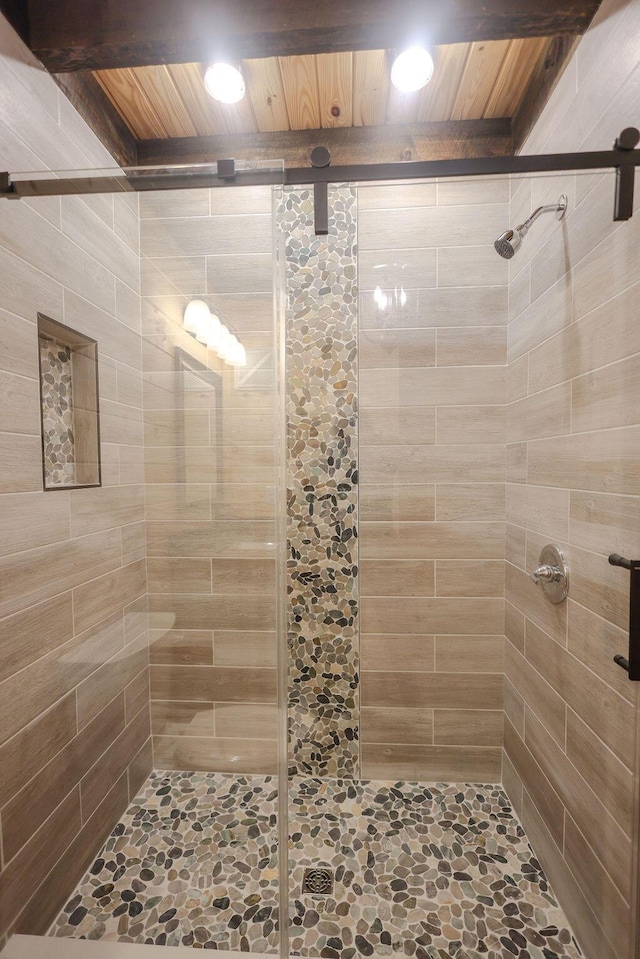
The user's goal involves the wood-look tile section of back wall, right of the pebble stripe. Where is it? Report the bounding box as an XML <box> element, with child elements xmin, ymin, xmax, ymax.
<box><xmin>358</xmin><ymin>180</ymin><xmax>509</xmax><ymax>782</ymax></box>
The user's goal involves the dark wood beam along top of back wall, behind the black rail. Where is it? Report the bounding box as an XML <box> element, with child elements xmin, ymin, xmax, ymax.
<box><xmin>138</xmin><ymin>119</ymin><xmax>513</xmax><ymax>167</ymax></box>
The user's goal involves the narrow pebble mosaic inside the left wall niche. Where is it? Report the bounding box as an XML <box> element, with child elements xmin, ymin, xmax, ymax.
<box><xmin>40</xmin><ymin>339</ymin><xmax>75</xmax><ymax>486</ymax></box>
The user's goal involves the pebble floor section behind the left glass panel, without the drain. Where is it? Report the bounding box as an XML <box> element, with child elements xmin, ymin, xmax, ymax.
<box><xmin>53</xmin><ymin>772</ymin><xmax>278</xmax><ymax>953</ymax></box>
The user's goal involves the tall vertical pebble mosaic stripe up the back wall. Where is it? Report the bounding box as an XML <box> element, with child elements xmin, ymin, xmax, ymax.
<box><xmin>278</xmin><ymin>186</ymin><xmax>359</xmax><ymax>778</ymax></box>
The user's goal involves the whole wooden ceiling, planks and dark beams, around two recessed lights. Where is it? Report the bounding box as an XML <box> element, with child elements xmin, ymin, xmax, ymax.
<box><xmin>0</xmin><ymin>0</ymin><xmax>600</xmax><ymax>166</ymax></box>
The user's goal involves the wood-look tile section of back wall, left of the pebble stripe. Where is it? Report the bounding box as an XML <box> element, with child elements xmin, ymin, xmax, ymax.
<box><xmin>140</xmin><ymin>187</ymin><xmax>277</xmax><ymax>773</ymax></box>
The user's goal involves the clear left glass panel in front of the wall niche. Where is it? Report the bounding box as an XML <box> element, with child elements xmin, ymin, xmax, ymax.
<box><xmin>0</xmin><ymin>164</ymin><xmax>286</xmax><ymax>955</ymax></box>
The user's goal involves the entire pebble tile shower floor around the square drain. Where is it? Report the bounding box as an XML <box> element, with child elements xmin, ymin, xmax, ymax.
<box><xmin>51</xmin><ymin>772</ymin><xmax>581</xmax><ymax>959</ymax></box>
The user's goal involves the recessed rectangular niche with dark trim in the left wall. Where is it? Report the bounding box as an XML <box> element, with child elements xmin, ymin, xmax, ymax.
<box><xmin>38</xmin><ymin>313</ymin><xmax>101</xmax><ymax>490</ymax></box>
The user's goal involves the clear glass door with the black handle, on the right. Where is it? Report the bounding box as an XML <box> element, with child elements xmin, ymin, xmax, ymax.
<box><xmin>278</xmin><ymin>174</ymin><xmax>640</xmax><ymax>959</ymax></box>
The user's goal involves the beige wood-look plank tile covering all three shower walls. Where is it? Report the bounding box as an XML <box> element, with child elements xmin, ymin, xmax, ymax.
<box><xmin>0</xmin><ymin>0</ymin><xmax>640</xmax><ymax>959</ymax></box>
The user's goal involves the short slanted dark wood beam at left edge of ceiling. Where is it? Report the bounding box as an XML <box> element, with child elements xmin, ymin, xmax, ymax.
<box><xmin>54</xmin><ymin>72</ymin><xmax>138</xmax><ymax>166</ymax></box>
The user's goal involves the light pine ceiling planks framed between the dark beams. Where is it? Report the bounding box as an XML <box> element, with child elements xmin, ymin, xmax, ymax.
<box><xmin>94</xmin><ymin>37</ymin><xmax>552</xmax><ymax>140</ymax></box>
